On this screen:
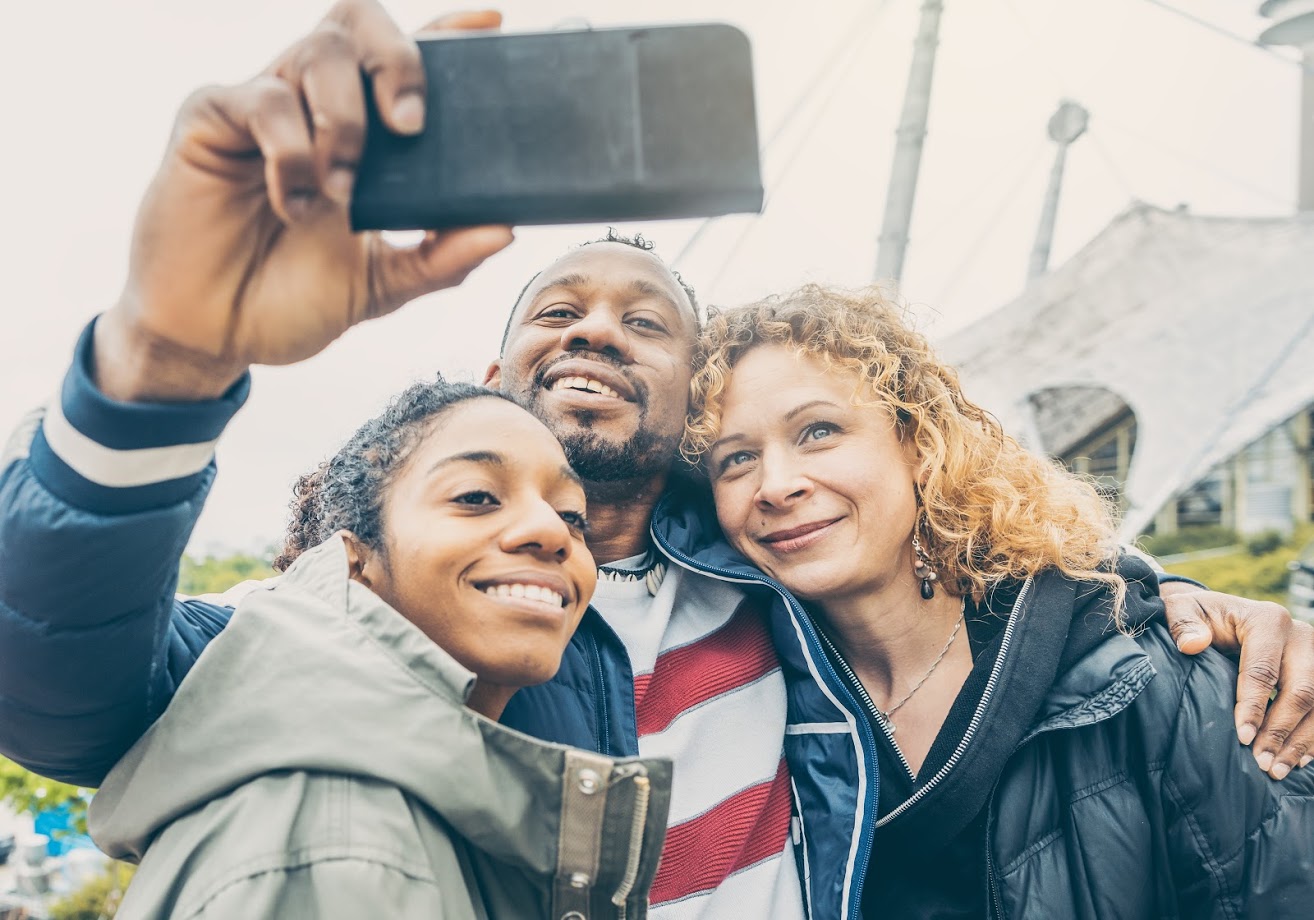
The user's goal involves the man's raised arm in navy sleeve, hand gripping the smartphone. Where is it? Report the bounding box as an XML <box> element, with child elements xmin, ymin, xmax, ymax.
<box><xmin>0</xmin><ymin>0</ymin><xmax>511</xmax><ymax>785</ymax></box>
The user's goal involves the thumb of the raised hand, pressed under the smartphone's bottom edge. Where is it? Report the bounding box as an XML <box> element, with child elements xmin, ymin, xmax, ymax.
<box><xmin>371</xmin><ymin>226</ymin><xmax>515</xmax><ymax>315</ymax></box>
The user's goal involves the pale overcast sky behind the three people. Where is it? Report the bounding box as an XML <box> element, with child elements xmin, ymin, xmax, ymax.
<box><xmin>0</xmin><ymin>0</ymin><xmax>1300</xmax><ymax>552</ymax></box>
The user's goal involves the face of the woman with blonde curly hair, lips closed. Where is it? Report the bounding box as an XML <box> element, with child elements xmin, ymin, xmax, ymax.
<box><xmin>707</xmin><ymin>344</ymin><xmax>917</xmax><ymax>605</ymax></box>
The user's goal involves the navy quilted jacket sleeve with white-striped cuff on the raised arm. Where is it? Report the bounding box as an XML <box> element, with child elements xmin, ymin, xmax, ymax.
<box><xmin>0</xmin><ymin>327</ymin><xmax>250</xmax><ymax>786</ymax></box>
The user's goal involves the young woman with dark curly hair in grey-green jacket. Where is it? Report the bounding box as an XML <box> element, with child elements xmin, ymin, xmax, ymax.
<box><xmin>91</xmin><ymin>380</ymin><xmax>669</xmax><ymax>920</ymax></box>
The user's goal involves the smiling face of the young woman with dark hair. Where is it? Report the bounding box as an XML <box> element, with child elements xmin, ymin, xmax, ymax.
<box><xmin>355</xmin><ymin>397</ymin><xmax>597</xmax><ymax>687</ymax></box>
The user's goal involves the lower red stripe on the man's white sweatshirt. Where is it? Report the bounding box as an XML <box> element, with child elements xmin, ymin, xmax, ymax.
<box><xmin>650</xmin><ymin>758</ymin><xmax>790</xmax><ymax>904</ymax></box>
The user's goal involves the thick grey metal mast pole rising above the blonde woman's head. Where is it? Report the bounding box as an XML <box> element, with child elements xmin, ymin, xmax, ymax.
<box><xmin>876</xmin><ymin>0</ymin><xmax>945</xmax><ymax>281</ymax></box>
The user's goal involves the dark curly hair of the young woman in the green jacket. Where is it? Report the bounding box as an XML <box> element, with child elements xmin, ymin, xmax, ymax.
<box><xmin>273</xmin><ymin>376</ymin><xmax>515</xmax><ymax>572</ymax></box>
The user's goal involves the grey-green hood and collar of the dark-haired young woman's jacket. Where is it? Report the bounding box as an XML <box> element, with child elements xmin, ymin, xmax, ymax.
<box><xmin>89</xmin><ymin>538</ymin><xmax>670</xmax><ymax>882</ymax></box>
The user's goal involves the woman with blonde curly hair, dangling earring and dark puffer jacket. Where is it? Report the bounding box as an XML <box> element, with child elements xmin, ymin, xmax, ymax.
<box><xmin>685</xmin><ymin>285</ymin><xmax>1314</xmax><ymax>919</ymax></box>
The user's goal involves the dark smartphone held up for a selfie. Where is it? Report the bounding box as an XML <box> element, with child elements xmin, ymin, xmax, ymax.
<box><xmin>351</xmin><ymin>24</ymin><xmax>762</xmax><ymax>230</ymax></box>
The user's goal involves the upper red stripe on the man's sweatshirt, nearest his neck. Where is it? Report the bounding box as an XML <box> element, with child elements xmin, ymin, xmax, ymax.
<box><xmin>635</xmin><ymin>601</ymin><xmax>781</xmax><ymax>737</ymax></box>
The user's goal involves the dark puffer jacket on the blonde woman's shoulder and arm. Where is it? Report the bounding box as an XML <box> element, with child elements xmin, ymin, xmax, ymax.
<box><xmin>987</xmin><ymin>574</ymin><xmax>1314</xmax><ymax>920</ymax></box>
